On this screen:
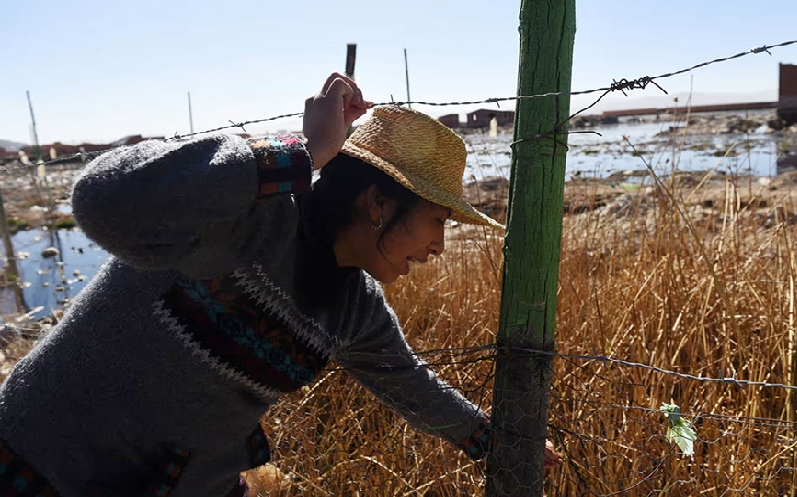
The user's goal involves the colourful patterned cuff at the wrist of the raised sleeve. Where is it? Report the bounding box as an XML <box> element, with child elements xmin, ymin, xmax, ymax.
<box><xmin>247</xmin><ymin>135</ymin><xmax>313</xmax><ymax>201</ymax></box>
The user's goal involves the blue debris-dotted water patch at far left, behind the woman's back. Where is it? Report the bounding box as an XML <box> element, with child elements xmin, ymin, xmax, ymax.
<box><xmin>0</xmin><ymin>229</ymin><xmax>108</xmax><ymax>318</ymax></box>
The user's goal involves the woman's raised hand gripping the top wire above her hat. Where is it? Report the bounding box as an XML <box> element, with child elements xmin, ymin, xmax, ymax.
<box><xmin>302</xmin><ymin>73</ymin><xmax>368</xmax><ymax>169</ymax></box>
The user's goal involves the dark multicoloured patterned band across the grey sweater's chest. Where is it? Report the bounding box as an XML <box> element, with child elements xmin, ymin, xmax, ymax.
<box><xmin>163</xmin><ymin>277</ymin><xmax>329</xmax><ymax>392</ymax></box>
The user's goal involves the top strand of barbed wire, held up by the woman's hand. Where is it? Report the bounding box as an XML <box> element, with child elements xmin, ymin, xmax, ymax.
<box><xmin>0</xmin><ymin>40</ymin><xmax>797</xmax><ymax>171</ymax></box>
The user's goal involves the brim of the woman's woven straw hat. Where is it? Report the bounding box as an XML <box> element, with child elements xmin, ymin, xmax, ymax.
<box><xmin>341</xmin><ymin>142</ymin><xmax>506</xmax><ymax>229</ymax></box>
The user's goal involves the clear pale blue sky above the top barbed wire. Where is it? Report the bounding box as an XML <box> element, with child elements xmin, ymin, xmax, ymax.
<box><xmin>0</xmin><ymin>0</ymin><xmax>797</xmax><ymax>143</ymax></box>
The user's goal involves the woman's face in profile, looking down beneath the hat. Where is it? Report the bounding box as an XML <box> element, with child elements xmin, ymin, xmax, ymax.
<box><xmin>363</xmin><ymin>200</ymin><xmax>451</xmax><ymax>283</ymax></box>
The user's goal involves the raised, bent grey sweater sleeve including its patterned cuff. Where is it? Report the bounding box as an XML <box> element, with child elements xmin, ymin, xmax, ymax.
<box><xmin>72</xmin><ymin>134</ymin><xmax>312</xmax><ymax>276</ymax></box>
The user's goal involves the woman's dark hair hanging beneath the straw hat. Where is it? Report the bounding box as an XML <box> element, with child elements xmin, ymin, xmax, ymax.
<box><xmin>297</xmin><ymin>153</ymin><xmax>421</xmax><ymax>307</ymax></box>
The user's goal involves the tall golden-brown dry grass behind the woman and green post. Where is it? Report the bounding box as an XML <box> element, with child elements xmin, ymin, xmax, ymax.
<box><xmin>247</xmin><ymin>170</ymin><xmax>797</xmax><ymax>497</ymax></box>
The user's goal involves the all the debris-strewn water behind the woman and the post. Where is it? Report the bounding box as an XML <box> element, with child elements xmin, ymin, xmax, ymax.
<box><xmin>0</xmin><ymin>121</ymin><xmax>778</xmax><ymax>318</ymax></box>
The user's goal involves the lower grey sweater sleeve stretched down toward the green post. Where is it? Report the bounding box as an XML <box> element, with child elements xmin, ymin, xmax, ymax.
<box><xmin>335</xmin><ymin>283</ymin><xmax>491</xmax><ymax>459</ymax></box>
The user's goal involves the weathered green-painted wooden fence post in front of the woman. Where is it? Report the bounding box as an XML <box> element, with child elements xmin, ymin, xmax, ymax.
<box><xmin>486</xmin><ymin>0</ymin><xmax>576</xmax><ymax>497</ymax></box>
